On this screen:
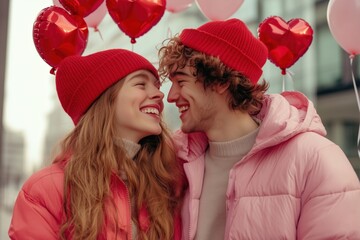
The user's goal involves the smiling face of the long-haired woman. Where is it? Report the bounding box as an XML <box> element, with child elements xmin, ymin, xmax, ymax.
<box><xmin>115</xmin><ymin>70</ymin><xmax>164</xmax><ymax>142</ymax></box>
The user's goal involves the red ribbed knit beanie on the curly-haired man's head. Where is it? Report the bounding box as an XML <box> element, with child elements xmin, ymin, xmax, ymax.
<box><xmin>180</xmin><ymin>19</ymin><xmax>268</xmax><ymax>84</ymax></box>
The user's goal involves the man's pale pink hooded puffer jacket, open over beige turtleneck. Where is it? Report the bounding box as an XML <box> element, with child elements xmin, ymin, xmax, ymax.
<box><xmin>174</xmin><ymin>92</ymin><xmax>360</xmax><ymax>240</ymax></box>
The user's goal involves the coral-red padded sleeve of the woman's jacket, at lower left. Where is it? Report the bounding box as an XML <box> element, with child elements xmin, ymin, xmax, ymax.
<box><xmin>8</xmin><ymin>167</ymin><xmax>63</xmax><ymax>240</ymax></box>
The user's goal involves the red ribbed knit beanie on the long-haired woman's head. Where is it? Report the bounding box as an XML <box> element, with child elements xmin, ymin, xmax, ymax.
<box><xmin>56</xmin><ymin>49</ymin><xmax>159</xmax><ymax>125</ymax></box>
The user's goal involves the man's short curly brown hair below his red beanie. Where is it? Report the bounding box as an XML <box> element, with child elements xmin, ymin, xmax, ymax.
<box><xmin>159</xmin><ymin>36</ymin><xmax>269</xmax><ymax>114</ymax></box>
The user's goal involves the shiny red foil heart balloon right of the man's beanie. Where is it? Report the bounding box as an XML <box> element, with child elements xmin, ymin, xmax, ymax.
<box><xmin>258</xmin><ymin>16</ymin><xmax>313</xmax><ymax>74</ymax></box>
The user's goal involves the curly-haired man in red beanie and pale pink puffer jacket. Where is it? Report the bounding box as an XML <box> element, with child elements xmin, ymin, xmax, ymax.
<box><xmin>159</xmin><ymin>19</ymin><xmax>360</xmax><ymax>240</ymax></box>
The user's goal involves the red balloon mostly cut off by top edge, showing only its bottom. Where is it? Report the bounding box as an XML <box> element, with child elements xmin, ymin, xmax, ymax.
<box><xmin>59</xmin><ymin>0</ymin><xmax>104</xmax><ymax>17</ymax></box>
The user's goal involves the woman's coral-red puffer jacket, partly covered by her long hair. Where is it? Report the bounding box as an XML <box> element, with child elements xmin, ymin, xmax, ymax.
<box><xmin>9</xmin><ymin>164</ymin><xmax>181</xmax><ymax>240</ymax></box>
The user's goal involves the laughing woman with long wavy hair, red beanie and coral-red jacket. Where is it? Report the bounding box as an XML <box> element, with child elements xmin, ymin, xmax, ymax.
<box><xmin>9</xmin><ymin>49</ymin><xmax>184</xmax><ymax>240</ymax></box>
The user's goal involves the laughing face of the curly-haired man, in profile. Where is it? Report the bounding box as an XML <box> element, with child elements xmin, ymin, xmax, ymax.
<box><xmin>167</xmin><ymin>66</ymin><xmax>217</xmax><ymax>133</ymax></box>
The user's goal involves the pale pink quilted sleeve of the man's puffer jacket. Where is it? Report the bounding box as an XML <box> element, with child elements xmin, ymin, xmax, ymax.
<box><xmin>297</xmin><ymin>144</ymin><xmax>360</xmax><ymax>239</ymax></box>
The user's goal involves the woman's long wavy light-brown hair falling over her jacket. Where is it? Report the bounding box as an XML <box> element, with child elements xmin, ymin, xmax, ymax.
<box><xmin>54</xmin><ymin>78</ymin><xmax>184</xmax><ymax>240</ymax></box>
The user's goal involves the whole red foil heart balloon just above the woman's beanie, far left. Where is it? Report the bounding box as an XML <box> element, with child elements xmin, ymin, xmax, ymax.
<box><xmin>33</xmin><ymin>6</ymin><xmax>89</xmax><ymax>71</ymax></box>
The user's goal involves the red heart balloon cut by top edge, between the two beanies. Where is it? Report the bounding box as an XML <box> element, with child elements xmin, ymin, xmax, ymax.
<box><xmin>106</xmin><ymin>0</ymin><xmax>166</xmax><ymax>43</ymax></box>
